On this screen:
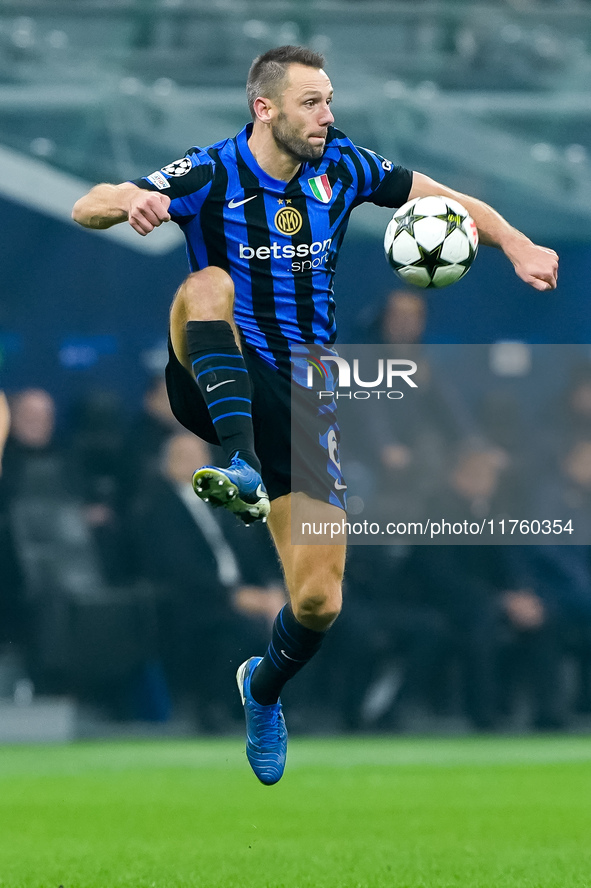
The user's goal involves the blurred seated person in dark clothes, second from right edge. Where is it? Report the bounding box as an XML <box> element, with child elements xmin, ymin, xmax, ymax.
<box><xmin>400</xmin><ymin>446</ymin><xmax>561</xmax><ymax>729</ymax></box>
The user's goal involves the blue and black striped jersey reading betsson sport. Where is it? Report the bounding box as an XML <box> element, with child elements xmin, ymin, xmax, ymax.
<box><xmin>134</xmin><ymin>124</ymin><xmax>412</xmax><ymax>366</ymax></box>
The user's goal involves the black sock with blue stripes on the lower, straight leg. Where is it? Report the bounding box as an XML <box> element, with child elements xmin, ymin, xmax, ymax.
<box><xmin>250</xmin><ymin>604</ymin><xmax>326</xmax><ymax>706</ymax></box>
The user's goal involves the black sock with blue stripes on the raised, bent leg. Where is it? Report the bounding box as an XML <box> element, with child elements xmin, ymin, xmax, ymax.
<box><xmin>187</xmin><ymin>321</ymin><xmax>261</xmax><ymax>472</ymax></box>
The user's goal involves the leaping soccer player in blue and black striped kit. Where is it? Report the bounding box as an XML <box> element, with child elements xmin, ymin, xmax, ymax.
<box><xmin>72</xmin><ymin>46</ymin><xmax>558</xmax><ymax>784</ymax></box>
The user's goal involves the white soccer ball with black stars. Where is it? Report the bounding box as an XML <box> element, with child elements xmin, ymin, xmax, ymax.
<box><xmin>384</xmin><ymin>195</ymin><xmax>478</xmax><ymax>287</ymax></box>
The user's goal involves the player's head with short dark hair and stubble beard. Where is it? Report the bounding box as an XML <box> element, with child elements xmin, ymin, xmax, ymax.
<box><xmin>246</xmin><ymin>46</ymin><xmax>334</xmax><ymax>160</ymax></box>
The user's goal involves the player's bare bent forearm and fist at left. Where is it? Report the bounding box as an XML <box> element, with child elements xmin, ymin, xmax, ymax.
<box><xmin>72</xmin><ymin>182</ymin><xmax>170</xmax><ymax>235</ymax></box>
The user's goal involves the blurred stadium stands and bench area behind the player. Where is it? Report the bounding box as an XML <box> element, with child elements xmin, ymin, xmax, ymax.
<box><xmin>0</xmin><ymin>0</ymin><xmax>591</xmax><ymax>741</ymax></box>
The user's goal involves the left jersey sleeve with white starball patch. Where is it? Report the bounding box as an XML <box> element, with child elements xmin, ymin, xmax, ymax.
<box><xmin>130</xmin><ymin>148</ymin><xmax>215</xmax><ymax>218</ymax></box>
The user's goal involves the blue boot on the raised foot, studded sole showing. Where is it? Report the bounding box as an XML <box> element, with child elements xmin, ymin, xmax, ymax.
<box><xmin>193</xmin><ymin>456</ymin><xmax>271</xmax><ymax>524</ymax></box>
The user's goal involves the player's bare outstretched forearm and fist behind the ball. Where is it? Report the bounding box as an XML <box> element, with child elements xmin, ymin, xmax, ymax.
<box><xmin>409</xmin><ymin>173</ymin><xmax>558</xmax><ymax>290</ymax></box>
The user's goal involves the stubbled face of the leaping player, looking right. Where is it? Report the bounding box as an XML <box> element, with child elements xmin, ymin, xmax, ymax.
<box><xmin>271</xmin><ymin>65</ymin><xmax>334</xmax><ymax>161</ymax></box>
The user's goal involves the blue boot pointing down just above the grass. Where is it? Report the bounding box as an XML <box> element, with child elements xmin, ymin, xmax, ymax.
<box><xmin>236</xmin><ymin>657</ymin><xmax>287</xmax><ymax>786</ymax></box>
